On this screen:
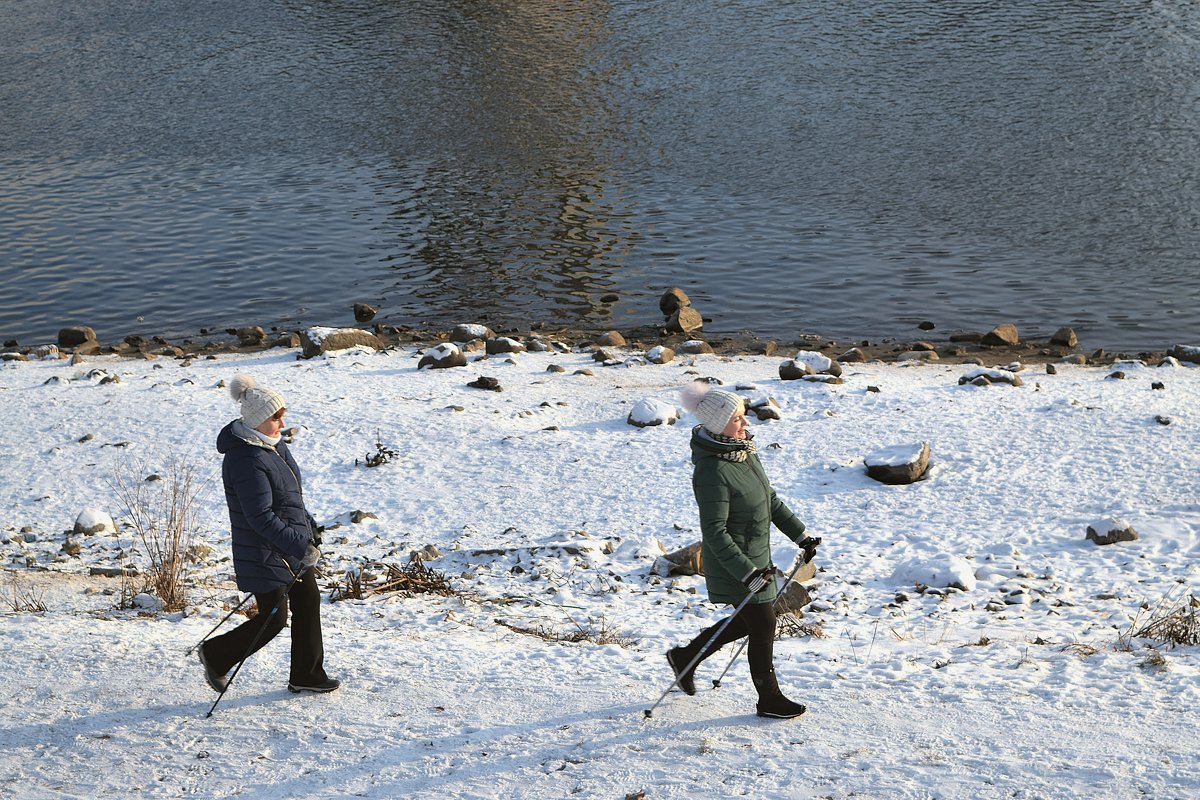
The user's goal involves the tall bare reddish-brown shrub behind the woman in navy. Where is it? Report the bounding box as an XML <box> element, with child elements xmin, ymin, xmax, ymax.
<box><xmin>112</xmin><ymin>458</ymin><xmax>206</xmax><ymax>612</ymax></box>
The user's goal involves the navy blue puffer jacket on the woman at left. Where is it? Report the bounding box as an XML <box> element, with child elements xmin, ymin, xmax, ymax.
<box><xmin>217</xmin><ymin>420</ymin><xmax>313</xmax><ymax>591</ymax></box>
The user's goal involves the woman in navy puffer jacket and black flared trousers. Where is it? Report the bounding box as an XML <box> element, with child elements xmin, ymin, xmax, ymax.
<box><xmin>199</xmin><ymin>374</ymin><xmax>341</xmax><ymax>692</ymax></box>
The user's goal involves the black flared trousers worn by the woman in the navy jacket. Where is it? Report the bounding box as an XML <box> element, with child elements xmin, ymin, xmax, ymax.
<box><xmin>203</xmin><ymin>570</ymin><xmax>329</xmax><ymax>686</ymax></box>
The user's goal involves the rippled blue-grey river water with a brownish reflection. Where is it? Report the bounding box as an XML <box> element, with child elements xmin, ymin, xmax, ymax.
<box><xmin>0</xmin><ymin>0</ymin><xmax>1200</xmax><ymax>349</ymax></box>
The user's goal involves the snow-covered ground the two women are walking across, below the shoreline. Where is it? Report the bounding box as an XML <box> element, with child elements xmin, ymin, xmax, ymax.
<box><xmin>0</xmin><ymin>349</ymin><xmax>1200</xmax><ymax>799</ymax></box>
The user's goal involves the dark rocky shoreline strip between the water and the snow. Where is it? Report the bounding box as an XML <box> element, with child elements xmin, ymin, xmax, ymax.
<box><xmin>0</xmin><ymin>323</ymin><xmax>1182</xmax><ymax>367</ymax></box>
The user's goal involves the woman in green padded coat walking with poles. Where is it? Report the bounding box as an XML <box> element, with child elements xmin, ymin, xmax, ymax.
<box><xmin>667</xmin><ymin>381</ymin><xmax>816</xmax><ymax>720</ymax></box>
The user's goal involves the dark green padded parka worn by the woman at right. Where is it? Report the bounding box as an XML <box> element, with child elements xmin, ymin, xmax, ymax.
<box><xmin>691</xmin><ymin>426</ymin><xmax>804</xmax><ymax>606</ymax></box>
